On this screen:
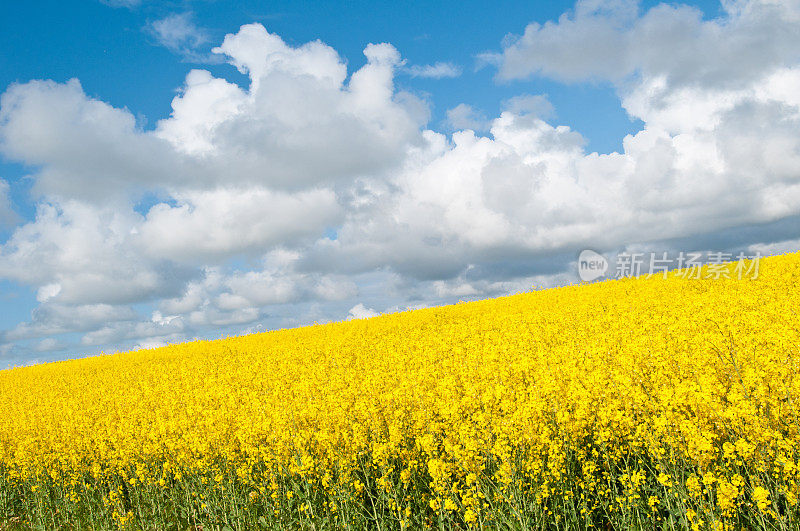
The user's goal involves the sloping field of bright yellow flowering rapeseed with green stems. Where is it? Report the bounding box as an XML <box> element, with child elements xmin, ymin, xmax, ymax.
<box><xmin>0</xmin><ymin>254</ymin><xmax>800</xmax><ymax>529</ymax></box>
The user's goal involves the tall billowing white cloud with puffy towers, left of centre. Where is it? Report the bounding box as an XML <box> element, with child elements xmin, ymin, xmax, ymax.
<box><xmin>156</xmin><ymin>24</ymin><xmax>426</xmax><ymax>190</ymax></box>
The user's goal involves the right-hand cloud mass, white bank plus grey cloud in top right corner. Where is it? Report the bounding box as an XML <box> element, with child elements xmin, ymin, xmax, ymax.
<box><xmin>300</xmin><ymin>2</ymin><xmax>800</xmax><ymax>282</ymax></box>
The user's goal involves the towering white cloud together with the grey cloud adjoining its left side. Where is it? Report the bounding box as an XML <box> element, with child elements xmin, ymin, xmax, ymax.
<box><xmin>0</xmin><ymin>25</ymin><xmax>427</xmax><ymax>202</ymax></box>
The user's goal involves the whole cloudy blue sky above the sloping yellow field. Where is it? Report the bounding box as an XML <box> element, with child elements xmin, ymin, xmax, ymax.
<box><xmin>0</xmin><ymin>0</ymin><xmax>800</xmax><ymax>363</ymax></box>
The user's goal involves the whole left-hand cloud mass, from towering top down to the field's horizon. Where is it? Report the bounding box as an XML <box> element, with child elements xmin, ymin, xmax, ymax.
<box><xmin>0</xmin><ymin>25</ymin><xmax>426</xmax><ymax>360</ymax></box>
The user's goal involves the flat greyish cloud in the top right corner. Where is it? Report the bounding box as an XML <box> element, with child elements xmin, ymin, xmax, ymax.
<box><xmin>484</xmin><ymin>0</ymin><xmax>800</xmax><ymax>87</ymax></box>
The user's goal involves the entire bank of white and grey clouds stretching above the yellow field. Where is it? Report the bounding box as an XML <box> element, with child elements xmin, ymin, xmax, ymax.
<box><xmin>0</xmin><ymin>7</ymin><xmax>800</xmax><ymax>366</ymax></box>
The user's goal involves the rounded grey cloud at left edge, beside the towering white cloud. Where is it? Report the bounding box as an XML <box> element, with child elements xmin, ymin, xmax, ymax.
<box><xmin>0</xmin><ymin>79</ymin><xmax>181</xmax><ymax>202</ymax></box>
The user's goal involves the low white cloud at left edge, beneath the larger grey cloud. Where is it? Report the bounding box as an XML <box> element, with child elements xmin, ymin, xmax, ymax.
<box><xmin>0</xmin><ymin>201</ymin><xmax>189</xmax><ymax>304</ymax></box>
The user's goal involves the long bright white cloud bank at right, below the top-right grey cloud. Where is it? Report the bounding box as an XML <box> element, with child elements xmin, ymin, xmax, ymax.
<box><xmin>310</xmin><ymin>82</ymin><xmax>800</xmax><ymax>278</ymax></box>
